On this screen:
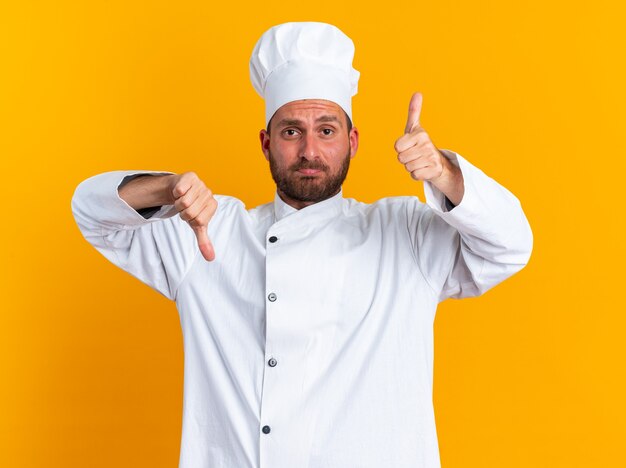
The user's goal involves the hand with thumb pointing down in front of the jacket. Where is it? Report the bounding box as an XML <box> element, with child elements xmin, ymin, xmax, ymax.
<box><xmin>168</xmin><ymin>172</ymin><xmax>217</xmax><ymax>261</ymax></box>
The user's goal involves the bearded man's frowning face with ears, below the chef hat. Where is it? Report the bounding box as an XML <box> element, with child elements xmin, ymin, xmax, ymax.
<box><xmin>260</xmin><ymin>99</ymin><xmax>358</xmax><ymax>209</ymax></box>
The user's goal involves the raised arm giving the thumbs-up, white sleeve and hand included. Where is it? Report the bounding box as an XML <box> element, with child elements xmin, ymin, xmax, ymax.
<box><xmin>395</xmin><ymin>93</ymin><xmax>533</xmax><ymax>300</ymax></box>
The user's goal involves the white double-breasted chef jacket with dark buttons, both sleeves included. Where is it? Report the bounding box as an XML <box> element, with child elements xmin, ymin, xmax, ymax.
<box><xmin>72</xmin><ymin>150</ymin><xmax>532</xmax><ymax>468</ymax></box>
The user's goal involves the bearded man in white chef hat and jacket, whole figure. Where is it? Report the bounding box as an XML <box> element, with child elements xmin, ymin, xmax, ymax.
<box><xmin>72</xmin><ymin>23</ymin><xmax>532</xmax><ymax>468</ymax></box>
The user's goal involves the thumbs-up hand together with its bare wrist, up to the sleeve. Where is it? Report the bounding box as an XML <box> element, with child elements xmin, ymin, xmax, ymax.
<box><xmin>394</xmin><ymin>93</ymin><xmax>463</xmax><ymax>205</ymax></box>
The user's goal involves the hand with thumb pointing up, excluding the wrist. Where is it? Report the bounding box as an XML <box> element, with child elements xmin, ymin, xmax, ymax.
<box><xmin>394</xmin><ymin>93</ymin><xmax>449</xmax><ymax>182</ymax></box>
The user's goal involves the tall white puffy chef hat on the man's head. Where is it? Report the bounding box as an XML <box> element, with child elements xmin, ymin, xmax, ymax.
<box><xmin>250</xmin><ymin>22</ymin><xmax>360</xmax><ymax>125</ymax></box>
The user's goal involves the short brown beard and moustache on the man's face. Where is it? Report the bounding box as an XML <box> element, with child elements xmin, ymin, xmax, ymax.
<box><xmin>269</xmin><ymin>149</ymin><xmax>350</xmax><ymax>203</ymax></box>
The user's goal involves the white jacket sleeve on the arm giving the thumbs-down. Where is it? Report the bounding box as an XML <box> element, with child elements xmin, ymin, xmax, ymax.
<box><xmin>71</xmin><ymin>171</ymin><xmax>199</xmax><ymax>300</ymax></box>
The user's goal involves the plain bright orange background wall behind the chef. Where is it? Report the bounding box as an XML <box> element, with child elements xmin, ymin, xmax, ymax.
<box><xmin>0</xmin><ymin>0</ymin><xmax>626</xmax><ymax>468</ymax></box>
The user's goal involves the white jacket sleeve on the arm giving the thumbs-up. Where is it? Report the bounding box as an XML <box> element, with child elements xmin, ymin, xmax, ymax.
<box><xmin>408</xmin><ymin>150</ymin><xmax>533</xmax><ymax>302</ymax></box>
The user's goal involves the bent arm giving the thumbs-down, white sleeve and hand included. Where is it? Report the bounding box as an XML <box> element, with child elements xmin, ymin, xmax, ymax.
<box><xmin>72</xmin><ymin>171</ymin><xmax>217</xmax><ymax>299</ymax></box>
